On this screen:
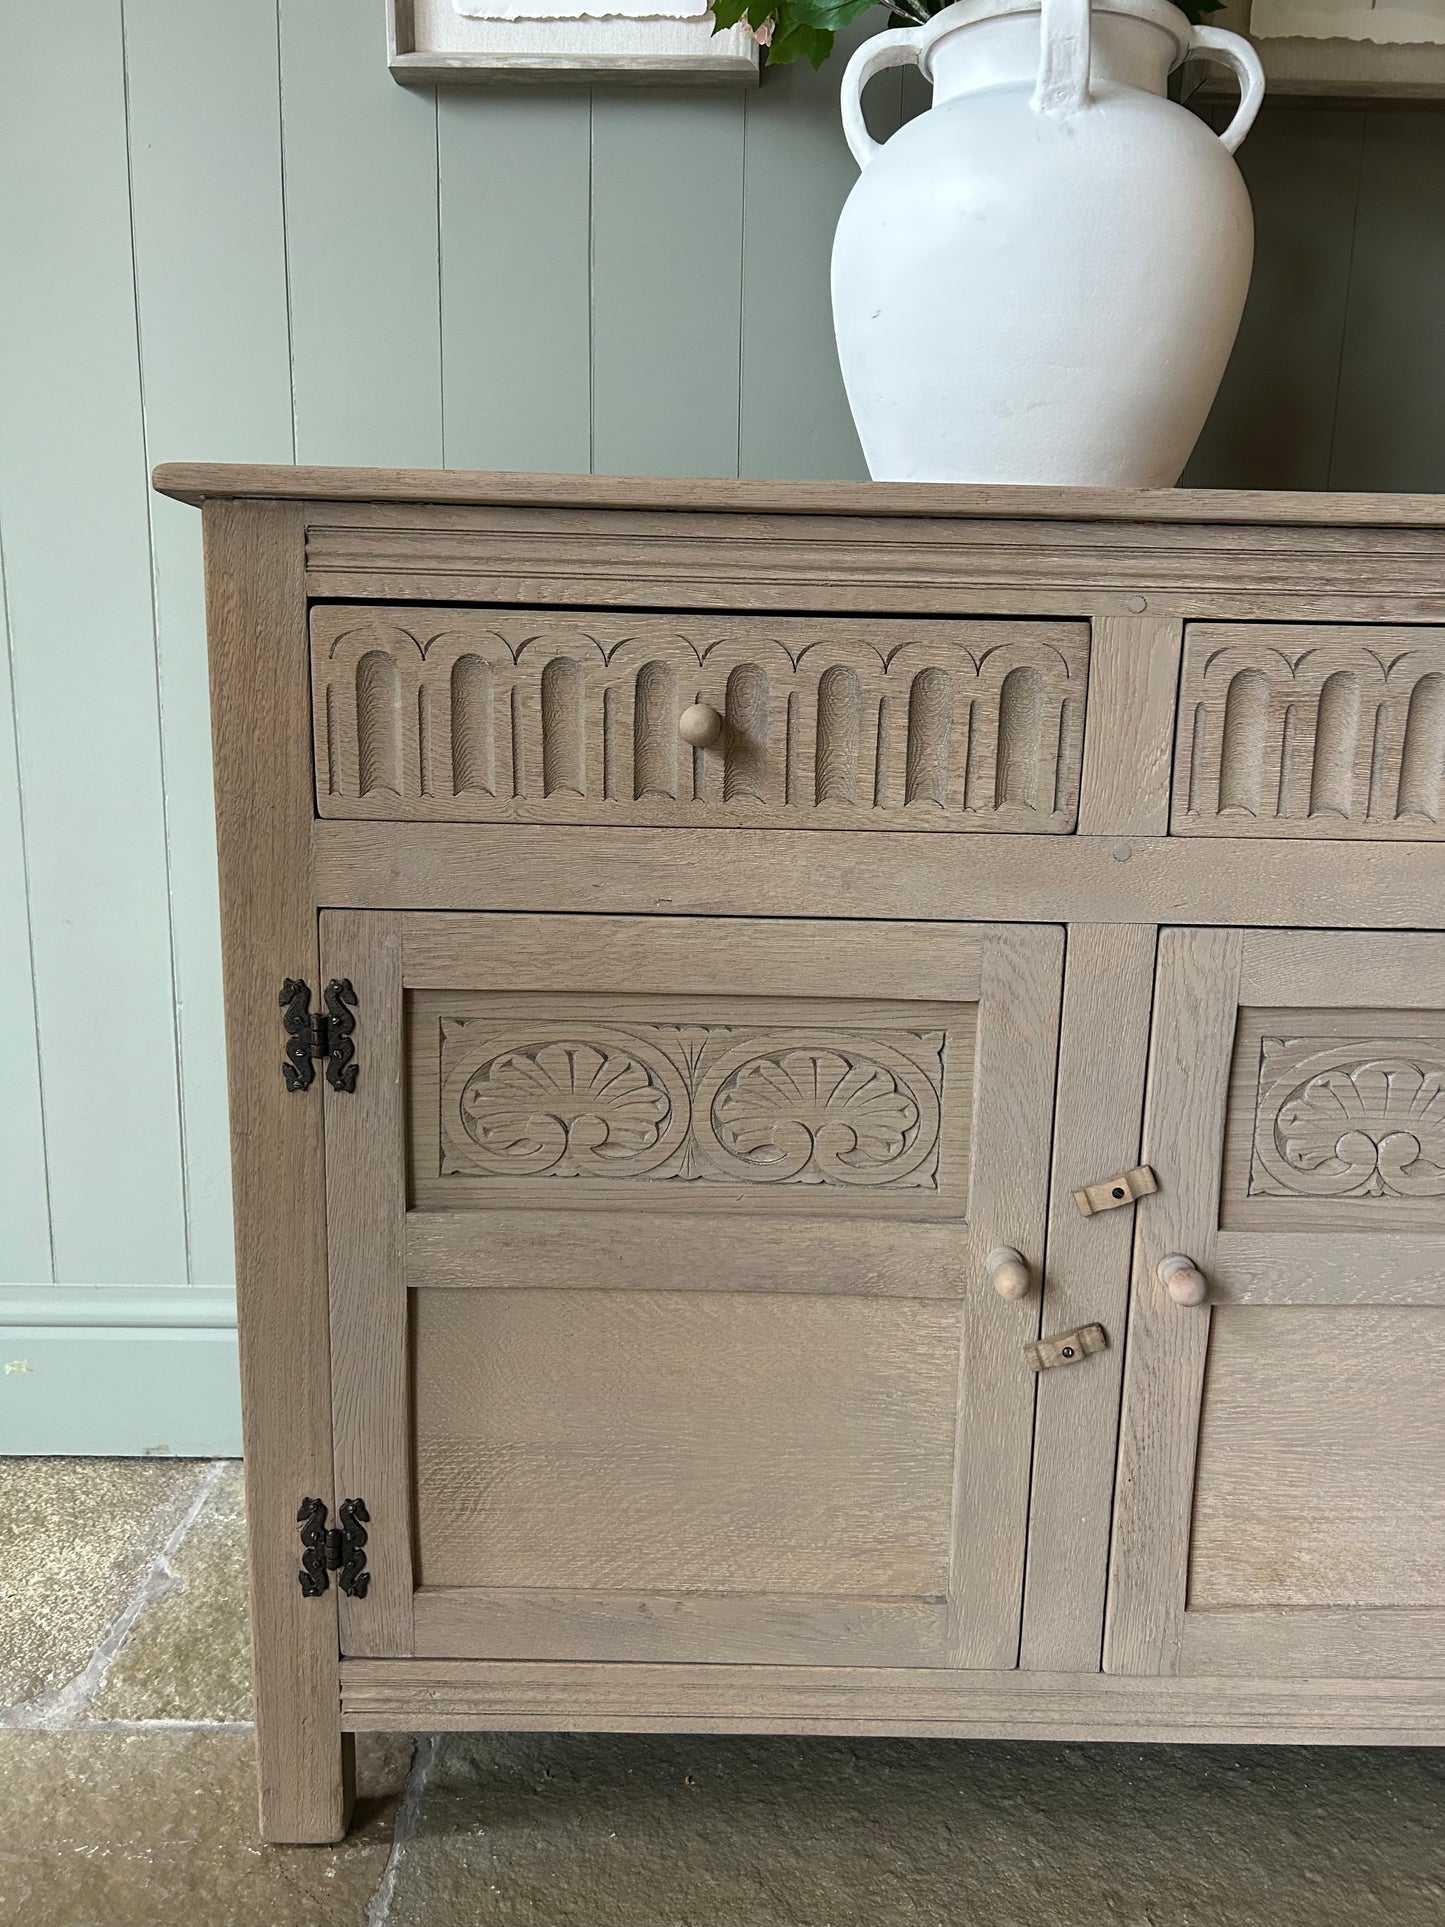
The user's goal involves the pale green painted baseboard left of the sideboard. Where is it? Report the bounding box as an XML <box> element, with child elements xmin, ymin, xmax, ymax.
<box><xmin>0</xmin><ymin>1285</ymin><xmax>241</xmax><ymax>1459</ymax></box>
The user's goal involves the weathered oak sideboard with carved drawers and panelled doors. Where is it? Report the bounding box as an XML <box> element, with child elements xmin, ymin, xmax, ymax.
<box><xmin>156</xmin><ymin>466</ymin><xmax>1445</xmax><ymax>1840</ymax></box>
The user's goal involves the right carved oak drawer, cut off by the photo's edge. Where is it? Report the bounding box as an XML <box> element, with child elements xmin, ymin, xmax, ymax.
<box><xmin>1171</xmin><ymin>622</ymin><xmax>1445</xmax><ymax>842</ymax></box>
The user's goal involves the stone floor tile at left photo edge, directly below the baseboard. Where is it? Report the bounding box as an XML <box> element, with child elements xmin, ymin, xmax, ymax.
<box><xmin>0</xmin><ymin>1459</ymin><xmax>206</xmax><ymax>1709</ymax></box>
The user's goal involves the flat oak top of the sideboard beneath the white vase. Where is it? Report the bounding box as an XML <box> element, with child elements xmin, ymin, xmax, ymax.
<box><xmin>152</xmin><ymin>462</ymin><xmax>1445</xmax><ymax>528</ymax></box>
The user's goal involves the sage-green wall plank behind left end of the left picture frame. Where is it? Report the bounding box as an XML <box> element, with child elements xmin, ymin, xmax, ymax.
<box><xmin>279</xmin><ymin>0</ymin><xmax>441</xmax><ymax>468</ymax></box>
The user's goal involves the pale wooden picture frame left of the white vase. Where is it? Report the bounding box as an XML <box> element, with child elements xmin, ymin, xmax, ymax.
<box><xmin>387</xmin><ymin>0</ymin><xmax>759</xmax><ymax>87</ymax></box>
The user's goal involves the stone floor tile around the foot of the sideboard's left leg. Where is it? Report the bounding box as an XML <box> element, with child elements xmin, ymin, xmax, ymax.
<box><xmin>0</xmin><ymin>1729</ymin><xmax>410</xmax><ymax>1927</ymax></box>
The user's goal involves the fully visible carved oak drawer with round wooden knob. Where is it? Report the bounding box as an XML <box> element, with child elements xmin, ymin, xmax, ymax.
<box><xmin>310</xmin><ymin>605</ymin><xmax>1089</xmax><ymax>832</ymax></box>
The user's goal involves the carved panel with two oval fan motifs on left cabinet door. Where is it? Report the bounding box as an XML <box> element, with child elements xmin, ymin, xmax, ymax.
<box><xmin>435</xmin><ymin>1017</ymin><xmax>946</xmax><ymax>1191</ymax></box>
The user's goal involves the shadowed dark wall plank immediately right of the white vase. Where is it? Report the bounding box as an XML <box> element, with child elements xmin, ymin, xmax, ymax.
<box><xmin>1183</xmin><ymin>106</ymin><xmax>1378</xmax><ymax>488</ymax></box>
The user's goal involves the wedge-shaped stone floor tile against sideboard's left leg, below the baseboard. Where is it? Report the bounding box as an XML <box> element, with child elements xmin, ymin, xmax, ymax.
<box><xmin>91</xmin><ymin>1461</ymin><xmax>250</xmax><ymax>1721</ymax></box>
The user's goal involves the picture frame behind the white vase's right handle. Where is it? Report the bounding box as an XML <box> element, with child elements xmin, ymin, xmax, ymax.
<box><xmin>1198</xmin><ymin>0</ymin><xmax>1445</xmax><ymax>100</ymax></box>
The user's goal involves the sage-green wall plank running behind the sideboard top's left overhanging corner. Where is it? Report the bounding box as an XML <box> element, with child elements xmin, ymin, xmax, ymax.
<box><xmin>125</xmin><ymin>0</ymin><xmax>300</xmax><ymax>1285</ymax></box>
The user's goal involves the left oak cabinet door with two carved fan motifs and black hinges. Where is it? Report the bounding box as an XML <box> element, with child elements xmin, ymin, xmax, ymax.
<box><xmin>322</xmin><ymin>913</ymin><xmax>1064</xmax><ymax>1667</ymax></box>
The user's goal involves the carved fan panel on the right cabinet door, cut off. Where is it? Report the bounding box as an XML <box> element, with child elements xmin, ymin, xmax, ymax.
<box><xmin>1250</xmin><ymin>1037</ymin><xmax>1445</xmax><ymax>1199</ymax></box>
